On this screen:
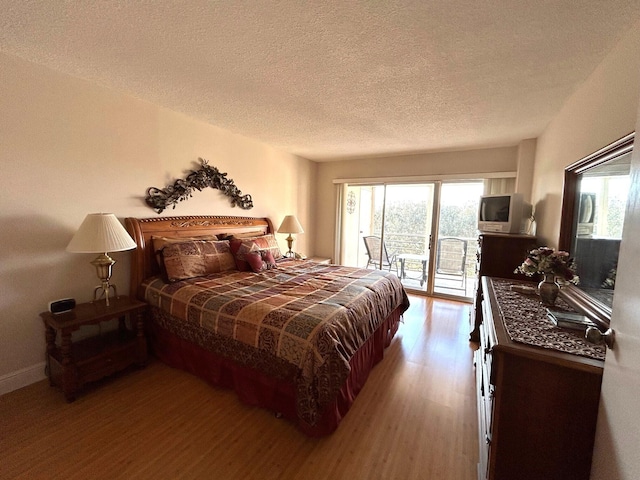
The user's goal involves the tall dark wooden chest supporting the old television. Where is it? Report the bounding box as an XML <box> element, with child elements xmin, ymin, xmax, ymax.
<box><xmin>469</xmin><ymin>233</ymin><xmax>538</xmax><ymax>342</ymax></box>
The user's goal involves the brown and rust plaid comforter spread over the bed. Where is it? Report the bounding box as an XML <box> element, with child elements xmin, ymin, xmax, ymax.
<box><xmin>144</xmin><ymin>261</ymin><xmax>409</xmax><ymax>425</ymax></box>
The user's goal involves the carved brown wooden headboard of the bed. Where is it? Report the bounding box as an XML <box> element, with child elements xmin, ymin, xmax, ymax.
<box><xmin>125</xmin><ymin>215</ymin><xmax>274</xmax><ymax>298</ymax></box>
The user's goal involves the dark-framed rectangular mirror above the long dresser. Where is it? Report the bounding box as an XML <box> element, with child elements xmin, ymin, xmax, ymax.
<box><xmin>558</xmin><ymin>133</ymin><xmax>634</xmax><ymax>327</ymax></box>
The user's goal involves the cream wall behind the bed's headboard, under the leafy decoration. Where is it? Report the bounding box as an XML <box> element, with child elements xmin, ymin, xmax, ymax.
<box><xmin>0</xmin><ymin>55</ymin><xmax>316</xmax><ymax>394</ymax></box>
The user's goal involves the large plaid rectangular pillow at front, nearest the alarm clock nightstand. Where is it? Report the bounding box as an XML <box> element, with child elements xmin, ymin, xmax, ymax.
<box><xmin>162</xmin><ymin>240</ymin><xmax>236</xmax><ymax>282</ymax></box>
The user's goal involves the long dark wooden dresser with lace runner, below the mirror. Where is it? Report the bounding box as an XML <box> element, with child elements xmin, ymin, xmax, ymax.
<box><xmin>474</xmin><ymin>277</ymin><xmax>604</xmax><ymax>480</ymax></box>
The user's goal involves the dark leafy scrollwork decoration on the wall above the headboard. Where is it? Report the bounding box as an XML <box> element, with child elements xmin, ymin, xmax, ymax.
<box><xmin>145</xmin><ymin>158</ymin><xmax>253</xmax><ymax>213</ymax></box>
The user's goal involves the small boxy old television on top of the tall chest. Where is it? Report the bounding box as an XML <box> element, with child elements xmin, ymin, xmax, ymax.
<box><xmin>478</xmin><ymin>193</ymin><xmax>530</xmax><ymax>233</ymax></box>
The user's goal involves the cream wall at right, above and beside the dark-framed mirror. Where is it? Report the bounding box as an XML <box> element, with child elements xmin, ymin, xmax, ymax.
<box><xmin>533</xmin><ymin>22</ymin><xmax>640</xmax><ymax>247</ymax></box>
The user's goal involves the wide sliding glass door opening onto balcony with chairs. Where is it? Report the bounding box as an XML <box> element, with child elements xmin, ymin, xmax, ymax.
<box><xmin>340</xmin><ymin>181</ymin><xmax>483</xmax><ymax>298</ymax></box>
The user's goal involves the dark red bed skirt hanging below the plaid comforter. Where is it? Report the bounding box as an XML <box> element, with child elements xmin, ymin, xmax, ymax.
<box><xmin>149</xmin><ymin>307</ymin><xmax>403</xmax><ymax>437</ymax></box>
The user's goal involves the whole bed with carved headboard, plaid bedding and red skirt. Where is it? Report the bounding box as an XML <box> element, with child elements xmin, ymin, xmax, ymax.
<box><xmin>125</xmin><ymin>216</ymin><xmax>409</xmax><ymax>436</ymax></box>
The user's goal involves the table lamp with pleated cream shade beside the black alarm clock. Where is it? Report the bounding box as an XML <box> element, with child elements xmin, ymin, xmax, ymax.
<box><xmin>67</xmin><ymin>213</ymin><xmax>136</xmax><ymax>306</ymax></box>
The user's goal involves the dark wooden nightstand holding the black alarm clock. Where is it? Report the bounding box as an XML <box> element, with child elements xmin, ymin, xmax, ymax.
<box><xmin>40</xmin><ymin>296</ymin><xmax>147</xmax><ymax>402</ymax></box>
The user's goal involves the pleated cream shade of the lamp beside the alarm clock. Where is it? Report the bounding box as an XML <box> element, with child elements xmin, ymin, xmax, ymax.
<box><xmin>67</xmin><ymin>213</ymin><xmax>136</xmax><ymax>253</ymax></box>
